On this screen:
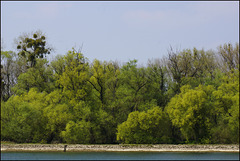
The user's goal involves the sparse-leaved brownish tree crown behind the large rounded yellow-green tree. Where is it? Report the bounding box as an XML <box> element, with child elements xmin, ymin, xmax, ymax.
<box><xmin>166</xmin><ymin>48</ymin><xmax>218</xmax><ymax>95</ymax></box>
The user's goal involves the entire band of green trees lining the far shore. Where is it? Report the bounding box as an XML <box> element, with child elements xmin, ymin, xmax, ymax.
<box><xmin>1</xmin><ymin>32</ymin><xmax>239</xmax><ymax>144</ymax></box>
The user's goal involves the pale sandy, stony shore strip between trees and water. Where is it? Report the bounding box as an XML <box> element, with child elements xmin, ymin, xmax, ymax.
<box><xmin>1</xmin><ymin>144</ymin><xmax>239</xmax><ymax>152</ymax></box>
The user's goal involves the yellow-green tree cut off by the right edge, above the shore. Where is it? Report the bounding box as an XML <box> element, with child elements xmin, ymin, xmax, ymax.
<box><xmin>211</xmin><ymin>70</ymin><xmax>239</xmax><ymax>143</ymax></box>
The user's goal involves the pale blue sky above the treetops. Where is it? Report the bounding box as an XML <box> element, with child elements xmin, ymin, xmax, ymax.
<box><xmin>1</xmin><ymin>1</ymin><xmax>239</xmax><ymax>64</ymax></box>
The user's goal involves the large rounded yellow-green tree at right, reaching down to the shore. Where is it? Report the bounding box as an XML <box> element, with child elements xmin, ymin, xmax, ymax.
<box><xmin>166</xmin><ymin>85</ymin><xmax>214</xmax><ymax>142</ymax></box>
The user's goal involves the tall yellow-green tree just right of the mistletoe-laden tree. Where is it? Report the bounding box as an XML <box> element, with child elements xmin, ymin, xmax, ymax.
<box><xmin>57</xmin><ymin>51</ymin><xmax>89</xmax><ymax>105</ymax></box>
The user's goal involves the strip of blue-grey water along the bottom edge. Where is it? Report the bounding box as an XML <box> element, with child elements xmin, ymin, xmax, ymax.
<box><xmin>1</xmin><ymin>152</ymin><xmax>239</xmax><ymax>160</ymax></box>
